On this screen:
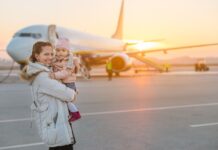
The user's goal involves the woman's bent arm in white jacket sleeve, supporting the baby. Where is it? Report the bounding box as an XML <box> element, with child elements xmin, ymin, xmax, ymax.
<box><xmin>37</xmin><ymin>72</ymin><xmax>76</xmax><ymax>101</ymax></box>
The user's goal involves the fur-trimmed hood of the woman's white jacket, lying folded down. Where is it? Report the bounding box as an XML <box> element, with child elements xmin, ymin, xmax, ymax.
<box><xmin>26</xmin><ymin>62</ymin><xmax>49</xmax><ymax>76</ymax></box>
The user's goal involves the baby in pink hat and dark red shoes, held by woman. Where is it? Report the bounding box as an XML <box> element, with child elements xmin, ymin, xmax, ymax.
<box><xmin>50</xmin><ymin>39</ymin><xmax>81</xmax><ymax>122</ymax></box>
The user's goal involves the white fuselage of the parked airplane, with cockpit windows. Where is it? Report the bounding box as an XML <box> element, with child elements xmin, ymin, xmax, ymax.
<box><xmin>7</xmin><ymin>25</ymin><xmax>125</xmax><ymax>64</ymax></box>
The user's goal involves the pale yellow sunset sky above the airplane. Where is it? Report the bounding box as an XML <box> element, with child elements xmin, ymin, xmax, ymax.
<box><xmin>0</xmin><ymin>0</ymin><xmax>218</xmax><ymax>57</ymax></box>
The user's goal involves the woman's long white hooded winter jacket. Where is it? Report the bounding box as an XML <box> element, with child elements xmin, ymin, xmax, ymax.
<box><xmin>26</xmin><ymin>63</ymin><xmax>75</xmax><ymax>147</ymax></box>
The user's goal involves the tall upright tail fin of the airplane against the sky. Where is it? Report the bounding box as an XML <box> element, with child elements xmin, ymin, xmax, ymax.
<box><xmin>112</xmin><ymin>0</ymin><xmax>124</xmax><ymax>39</ymax></box>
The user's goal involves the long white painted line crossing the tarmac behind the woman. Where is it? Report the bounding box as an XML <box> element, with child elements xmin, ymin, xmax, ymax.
<box><xmin>0</xmin><ymin>103</ymin><xmax>218</xmax><ymax>123</ymax></box>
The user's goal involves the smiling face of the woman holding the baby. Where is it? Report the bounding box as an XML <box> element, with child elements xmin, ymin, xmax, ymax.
<box><xmin>35</xmin><ymin>46</ymin><xmax>53</xmax><ymax>66</ymax></box>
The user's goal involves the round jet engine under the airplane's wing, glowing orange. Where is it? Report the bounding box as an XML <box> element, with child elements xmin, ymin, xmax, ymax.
<box><xmin>109</xmin><ymin>53</ymin><xmax>132</xmax><ymax>72</ymax></box>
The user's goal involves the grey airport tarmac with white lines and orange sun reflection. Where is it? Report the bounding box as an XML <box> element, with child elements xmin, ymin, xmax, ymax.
<box><xmin>0</xmin><ymin>67</ymin><xmax>218</xmax><ymax>150</ymax></box>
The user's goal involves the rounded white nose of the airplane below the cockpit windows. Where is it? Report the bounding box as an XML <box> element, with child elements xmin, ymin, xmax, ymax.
<box><xmin>6</xmin><ymin>38</ymin><xmax>35</xmax><ymax>63</ymax></box>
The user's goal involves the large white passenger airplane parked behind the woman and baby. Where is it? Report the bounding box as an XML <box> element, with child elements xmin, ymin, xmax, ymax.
<box><xmin>6</xmin><ymin>0</ymin><xmax>218</xmax><ymax>76</ymax></box>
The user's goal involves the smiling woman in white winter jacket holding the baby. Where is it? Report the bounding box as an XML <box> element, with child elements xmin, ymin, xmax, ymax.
<box><xmin>21</xmin><ymin>42</ymin><xmax>76</xmax><ymax>150</ymax></box>
